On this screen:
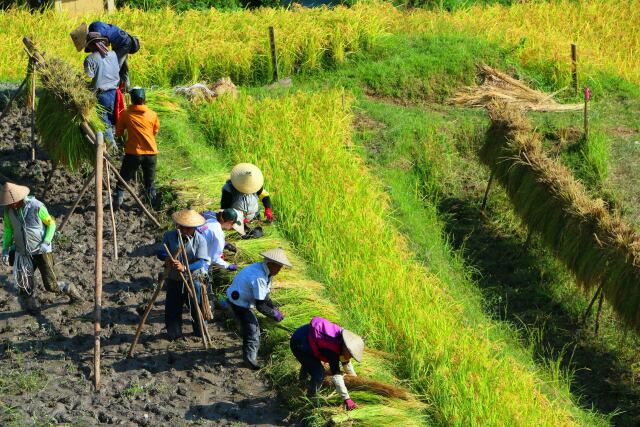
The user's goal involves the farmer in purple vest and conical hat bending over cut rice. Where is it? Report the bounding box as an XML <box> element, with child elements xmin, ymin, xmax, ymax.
<box><xmin>289</xmin><ymin>317</ymin><xmax>364</xmax><ymax>411</ymax></box>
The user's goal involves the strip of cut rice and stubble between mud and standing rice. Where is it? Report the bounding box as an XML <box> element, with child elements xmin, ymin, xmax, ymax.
<box><xmin>147</xmin><ymin>90</ymin><xmax>425</xmax><ymax>427</ymax></box>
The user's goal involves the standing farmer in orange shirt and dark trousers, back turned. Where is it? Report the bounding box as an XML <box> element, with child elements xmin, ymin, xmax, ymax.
<box><xmin>113</xmin><ymin>87</ymin><xmax>160</xmax><ymax>210</ymax></box>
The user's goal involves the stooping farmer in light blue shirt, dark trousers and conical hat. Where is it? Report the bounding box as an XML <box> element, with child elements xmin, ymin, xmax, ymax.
<box><xmin>222</xmin><ymin>248</ymin><xmax>291</xmax><ymax>369</ymax></box>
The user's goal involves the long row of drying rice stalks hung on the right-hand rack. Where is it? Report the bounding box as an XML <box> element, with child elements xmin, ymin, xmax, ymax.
<box><xmin>479</xmin><ymin>103</ymin><xmax>640</xmax><ymax>331</ymax></box>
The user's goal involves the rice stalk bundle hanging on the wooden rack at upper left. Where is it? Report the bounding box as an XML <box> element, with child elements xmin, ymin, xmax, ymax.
<box><xmin>36</xmin><ymin>58</ymin><xmax>104</xmax><ymax>170</ymax></box>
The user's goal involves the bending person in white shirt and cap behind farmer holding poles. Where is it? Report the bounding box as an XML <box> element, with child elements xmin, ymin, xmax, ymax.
<box><xmin>198</xmin><ymin>209</ymin><xmax>244</xmax><ymax>288</ymax></box>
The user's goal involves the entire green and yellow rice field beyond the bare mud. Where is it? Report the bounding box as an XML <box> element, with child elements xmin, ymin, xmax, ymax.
<box><xmin>0</xmin><ymin>0</ymin><xmax>640</xmax><ymax>426</ymax></box>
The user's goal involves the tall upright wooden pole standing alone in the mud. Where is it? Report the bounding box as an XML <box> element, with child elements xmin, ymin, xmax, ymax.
<box><xmin>93</xmin><ymin>132</ymin><xmax>104</xmax><ymax>391</ymax></box>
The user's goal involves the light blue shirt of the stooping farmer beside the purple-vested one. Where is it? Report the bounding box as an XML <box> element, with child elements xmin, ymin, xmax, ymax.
<box><xmin>227</xmin><ymin>262</ymin><xmax>271</xmax><ymax>308</ymax></box>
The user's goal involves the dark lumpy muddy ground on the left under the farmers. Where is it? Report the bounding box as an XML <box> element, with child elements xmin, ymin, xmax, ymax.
<box><xmin>0</xmin><ymin>109</ymin><xmax>290</xmax><ymax>426</ymax></box>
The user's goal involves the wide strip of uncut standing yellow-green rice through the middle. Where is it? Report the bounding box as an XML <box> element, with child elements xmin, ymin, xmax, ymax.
<box><xmin>195</xmin><ymin>91</ymin><xmax>605</xmax><ymax>425</ymax></box>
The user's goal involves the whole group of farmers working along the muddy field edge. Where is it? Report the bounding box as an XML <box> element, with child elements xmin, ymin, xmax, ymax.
<box><xmin>0</xmin><ymin>22</ymin><xmax>364</xmax><ymax>410</ymax></box>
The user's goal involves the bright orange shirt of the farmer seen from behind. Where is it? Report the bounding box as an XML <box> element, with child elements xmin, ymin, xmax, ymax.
<box><xmin>116</xmin><ymin>104</ymin><xmax>160</xmax><ymax>154</ymax></box>
